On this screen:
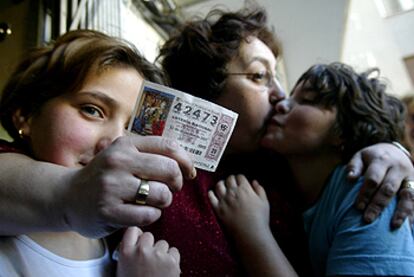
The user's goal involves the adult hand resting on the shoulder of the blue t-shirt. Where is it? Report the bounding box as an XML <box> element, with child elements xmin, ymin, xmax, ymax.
<box><xmin>348</xmin><ymin>143</ymin><xmax>414</xmax><ymax>227</ymax></box>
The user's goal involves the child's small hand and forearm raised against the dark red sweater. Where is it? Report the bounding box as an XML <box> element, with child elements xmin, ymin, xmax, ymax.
<box><xmin>209</xmin><ymin>175</ymin><xmax>297</xmax><ymax>276</ymax></box>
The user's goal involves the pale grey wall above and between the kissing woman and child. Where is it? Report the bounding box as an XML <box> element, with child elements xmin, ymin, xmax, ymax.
<box><xmin>184</xmin><ymin>0</ymin><xmax>348</xmax><ymax>88</ymax></box>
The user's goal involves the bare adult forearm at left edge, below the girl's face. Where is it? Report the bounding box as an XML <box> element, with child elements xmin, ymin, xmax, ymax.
<box><xmin>0</xmin><ymin>153</ymin><xmax>73</xmax><ymax>235</ymax></box>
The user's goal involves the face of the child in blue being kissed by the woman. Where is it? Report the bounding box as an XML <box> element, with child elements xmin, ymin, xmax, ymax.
<box><xmin>262</xmin><ymin>83</ymin><xmax>339</xmax><ymax>156</ymax></box>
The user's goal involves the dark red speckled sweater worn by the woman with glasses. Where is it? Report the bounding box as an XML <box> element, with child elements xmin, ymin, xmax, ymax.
<box><xmin>146</xmin><ymin>152</ymin><xmax>310</xmax><ymax>276</ymax></box>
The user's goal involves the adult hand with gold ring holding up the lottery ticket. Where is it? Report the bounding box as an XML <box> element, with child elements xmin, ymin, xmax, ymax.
<box><xmin>63</xmin><ymin>135</ymin><xmax>195</xmax><ymax>237</ymax></box>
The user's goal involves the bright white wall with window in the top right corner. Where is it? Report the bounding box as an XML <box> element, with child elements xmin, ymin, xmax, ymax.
<box><xmin>342</xmin><ymin>0</ymin><xmax>414</xmax><ymax>95</ymax></box>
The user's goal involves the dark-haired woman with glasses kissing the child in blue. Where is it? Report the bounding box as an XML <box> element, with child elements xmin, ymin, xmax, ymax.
<box><xmin>149</xmin><ymin>7</ymin><xmax>413</xmax><ymax>276</ymax></box>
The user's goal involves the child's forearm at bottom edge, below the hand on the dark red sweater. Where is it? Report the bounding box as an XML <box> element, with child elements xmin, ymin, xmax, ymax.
<box><xmin>235</xmin><ymin>226</ymin><xmax>298</xmax><ymax>277</ymax></box>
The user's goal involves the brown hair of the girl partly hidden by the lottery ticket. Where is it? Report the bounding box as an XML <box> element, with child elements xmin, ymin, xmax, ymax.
<box><xmin>0</xmin><ymin>30</ymin><xmax>164</xmax><ymax>146</ymax></box>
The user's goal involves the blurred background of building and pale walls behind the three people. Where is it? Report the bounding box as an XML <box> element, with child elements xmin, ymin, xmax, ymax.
<box><xmin>0</xmin><ymin>0</ymin><xmax>414</xmax><ymax>139</ymax></box>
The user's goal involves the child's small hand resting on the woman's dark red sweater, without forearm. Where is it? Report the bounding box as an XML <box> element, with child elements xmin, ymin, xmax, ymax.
<box><xmin>208</xmin><ymin>175</ymin><xmax>270</xmax><ymax>233</ymax></box>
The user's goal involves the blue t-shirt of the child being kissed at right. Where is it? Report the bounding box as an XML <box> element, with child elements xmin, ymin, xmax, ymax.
<box><xmin>303</xmin><ymin>166</ymin><xmax>414</xmax><ymax>276</ymax></box>
